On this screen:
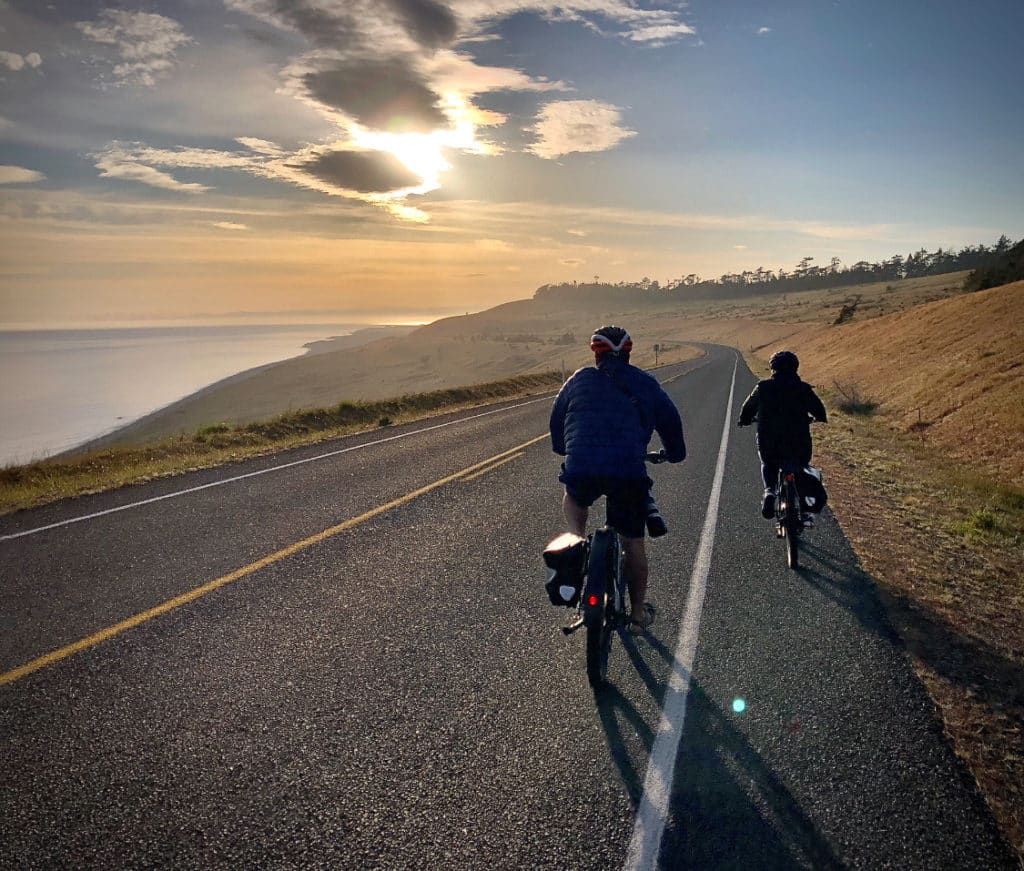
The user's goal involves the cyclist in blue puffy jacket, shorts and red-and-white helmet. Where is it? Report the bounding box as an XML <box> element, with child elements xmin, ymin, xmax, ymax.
<box><xmin>550</xmin><ymin>326</ymin><xmax>686</xmax><ymax>633</ymax></box>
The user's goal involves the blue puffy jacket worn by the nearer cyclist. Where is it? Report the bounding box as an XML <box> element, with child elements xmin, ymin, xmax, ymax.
<box><xmin>551</xmin><ymin>354</ymin><xmax>686</xmax><ymax>478</ymax></box>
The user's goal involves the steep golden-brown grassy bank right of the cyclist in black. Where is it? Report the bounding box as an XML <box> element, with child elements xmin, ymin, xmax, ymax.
<box><xmin>800</xmin><ymin>281</ymin><xmax>1024</xmax><ymax>486</ymax></box>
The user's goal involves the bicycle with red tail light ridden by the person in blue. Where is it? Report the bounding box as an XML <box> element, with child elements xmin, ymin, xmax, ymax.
<box><xmin>562</xmin><ymin>450</ymin><xmax>666</xmax><ymax>692</ymax></box>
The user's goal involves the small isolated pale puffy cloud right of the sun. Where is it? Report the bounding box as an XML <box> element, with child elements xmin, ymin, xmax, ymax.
<box><xmin>527</xmin><ymin>100</ymin><xmax>636</xmax><ymax>160</ymax></box>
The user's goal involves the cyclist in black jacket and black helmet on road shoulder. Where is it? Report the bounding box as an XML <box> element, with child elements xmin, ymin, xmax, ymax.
<box><xmin>737</xmin><ymin>351</ymin><xmax>828</xmax><ymax>520</ymax></box>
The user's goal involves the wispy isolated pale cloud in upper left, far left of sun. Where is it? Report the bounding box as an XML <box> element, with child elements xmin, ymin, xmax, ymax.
<box><xmin>75</xmin><ymin>9</ymin><xmax>193</xmax><ymax>87</ymax></box>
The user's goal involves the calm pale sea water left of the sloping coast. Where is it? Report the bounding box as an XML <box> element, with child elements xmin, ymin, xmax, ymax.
<box><xmin>0</xmin><ymin>323</ymin><xmax>367</xmax><ymax>465</ymax></box>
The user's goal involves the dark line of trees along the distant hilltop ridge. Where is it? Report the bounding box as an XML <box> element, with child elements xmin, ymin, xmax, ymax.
<box><xmin>534</xmin><ymin>235</ymin><xmax>1024</xmax><ymax>302</ymax></box>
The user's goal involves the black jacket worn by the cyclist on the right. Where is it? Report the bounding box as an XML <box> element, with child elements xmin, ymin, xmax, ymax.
<box><xmin>738</xmin><ymin>373</ymin><xmax>828</xmax><ymax>465</ymax></box>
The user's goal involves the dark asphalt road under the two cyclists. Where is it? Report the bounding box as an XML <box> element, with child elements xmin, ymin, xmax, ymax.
<box><xmin>0</xmin><ymin>347</ymin><xmax>1016</xmax><ymax>869</ymax></box>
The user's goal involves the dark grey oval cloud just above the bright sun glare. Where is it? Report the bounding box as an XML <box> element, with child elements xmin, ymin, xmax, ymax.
<box><xmin>302</xmin><ymin>60</ymin><xmax>447</xmax><ymax>133</ymax></box>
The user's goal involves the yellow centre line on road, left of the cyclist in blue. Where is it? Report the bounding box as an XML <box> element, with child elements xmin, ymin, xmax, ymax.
<box><xmin>0</xmin><ymin>433</ymin><xmax>548</xmax><ymax>686</ymax></box>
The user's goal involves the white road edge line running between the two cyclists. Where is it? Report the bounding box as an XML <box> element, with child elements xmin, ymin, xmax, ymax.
<box><xmin>625</xmin><ymin>357</ymin><xmax>739</xmax><ymax>871</ymax></box>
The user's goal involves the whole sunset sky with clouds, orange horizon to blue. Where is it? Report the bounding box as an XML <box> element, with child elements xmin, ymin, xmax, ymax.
<box><xmin>0</xmin><ymin>0</ymin><xmax>1024</xmax><ymax>328</ymax></box>
